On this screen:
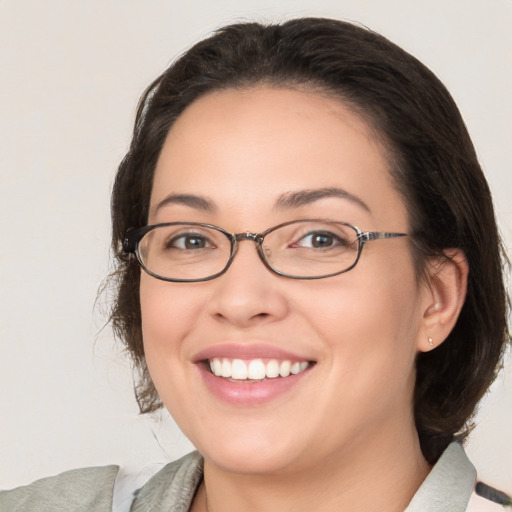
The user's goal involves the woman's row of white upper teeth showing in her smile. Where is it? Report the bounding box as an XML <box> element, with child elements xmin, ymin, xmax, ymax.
<box><xmin>210</xmin><ymin>357</ymin><xmax>309</xmax><ymax>380</ymax></box>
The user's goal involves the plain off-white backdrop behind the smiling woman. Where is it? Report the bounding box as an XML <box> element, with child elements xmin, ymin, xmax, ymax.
<box><xmin>0</xmin><ymin>0</ymin><xmax>512</xmax><ymax>492</ymax></box>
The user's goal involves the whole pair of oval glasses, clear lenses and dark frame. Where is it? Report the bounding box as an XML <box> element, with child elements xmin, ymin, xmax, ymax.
<box><xmin>123</xmin><ymin>219</ymin><xmax>407</xmax><ymax>283</ymax></box>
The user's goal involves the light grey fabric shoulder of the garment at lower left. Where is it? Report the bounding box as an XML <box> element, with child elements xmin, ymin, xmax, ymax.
<box><xmin>0</xmin><ymin>466</ymin><xmax>119</xmax><ymax>512</ymax></box>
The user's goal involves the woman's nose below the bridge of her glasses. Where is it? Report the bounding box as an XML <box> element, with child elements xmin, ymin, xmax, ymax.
<box><xmin>209</xmin><ymin>236</ymin><xmax>289</xmax><ymax>328</ymax></box>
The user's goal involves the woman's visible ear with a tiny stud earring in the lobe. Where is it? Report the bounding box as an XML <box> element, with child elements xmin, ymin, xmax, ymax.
<box><xmin>417</xmin><ymin>249</ymin><xmax>468</xmax><ymax>352</ymax></box>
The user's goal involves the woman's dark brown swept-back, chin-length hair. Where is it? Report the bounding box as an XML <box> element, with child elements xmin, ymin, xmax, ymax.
<box><xmin>111</xmin><ymin>18</ymin><xmax>507</xmax><ymax>463</ymax></box>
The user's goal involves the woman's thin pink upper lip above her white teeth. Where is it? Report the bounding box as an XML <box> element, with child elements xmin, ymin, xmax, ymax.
<box><xmin>193</xmin><ymin>343</ymin><xmax>313</xmax><ymax>363</ymax></box>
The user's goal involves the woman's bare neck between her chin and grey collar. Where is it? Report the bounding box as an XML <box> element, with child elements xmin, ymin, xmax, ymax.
<box><xmin>192</xmin><ymin>424</ymin><xmax>430</xmax><ymax>512</ymax></box>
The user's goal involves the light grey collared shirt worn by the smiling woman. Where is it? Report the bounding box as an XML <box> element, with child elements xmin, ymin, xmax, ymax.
<box><xmin>0</xmin><ymin>443</ymin><xmax>504</xmax><ymax>512</ymax></box>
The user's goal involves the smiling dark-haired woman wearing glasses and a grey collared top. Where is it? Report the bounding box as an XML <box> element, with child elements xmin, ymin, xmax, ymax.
<box><xmin>0</xmin><ymin>19</ymin><xmax>506</xmax><ymax>512</ymax></box>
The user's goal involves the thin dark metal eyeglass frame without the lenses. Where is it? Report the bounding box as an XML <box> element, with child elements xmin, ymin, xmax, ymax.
<box><xmin>122</xmin><ymin>219</ymin><xmax>409</xmax><ymax>283</ymax></box>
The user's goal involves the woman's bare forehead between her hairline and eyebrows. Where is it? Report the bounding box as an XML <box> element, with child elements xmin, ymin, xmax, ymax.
<box><xmin>151</xmin><ymin>87</ymin><xmax>403</xmax><ymax>228</ymax></box>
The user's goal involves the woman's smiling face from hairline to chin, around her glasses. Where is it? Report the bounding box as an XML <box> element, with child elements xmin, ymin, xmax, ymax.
<box><xmin>140</xmin><ymin>87</ymin><xmax>428</xmax><ymax>473</ymax></box>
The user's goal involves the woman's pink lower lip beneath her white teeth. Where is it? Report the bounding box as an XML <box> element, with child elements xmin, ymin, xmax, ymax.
<box><xmin>198</xmin><ymin>364</ymin><xmax>311</xmax><ymax>407</ymax></box>
